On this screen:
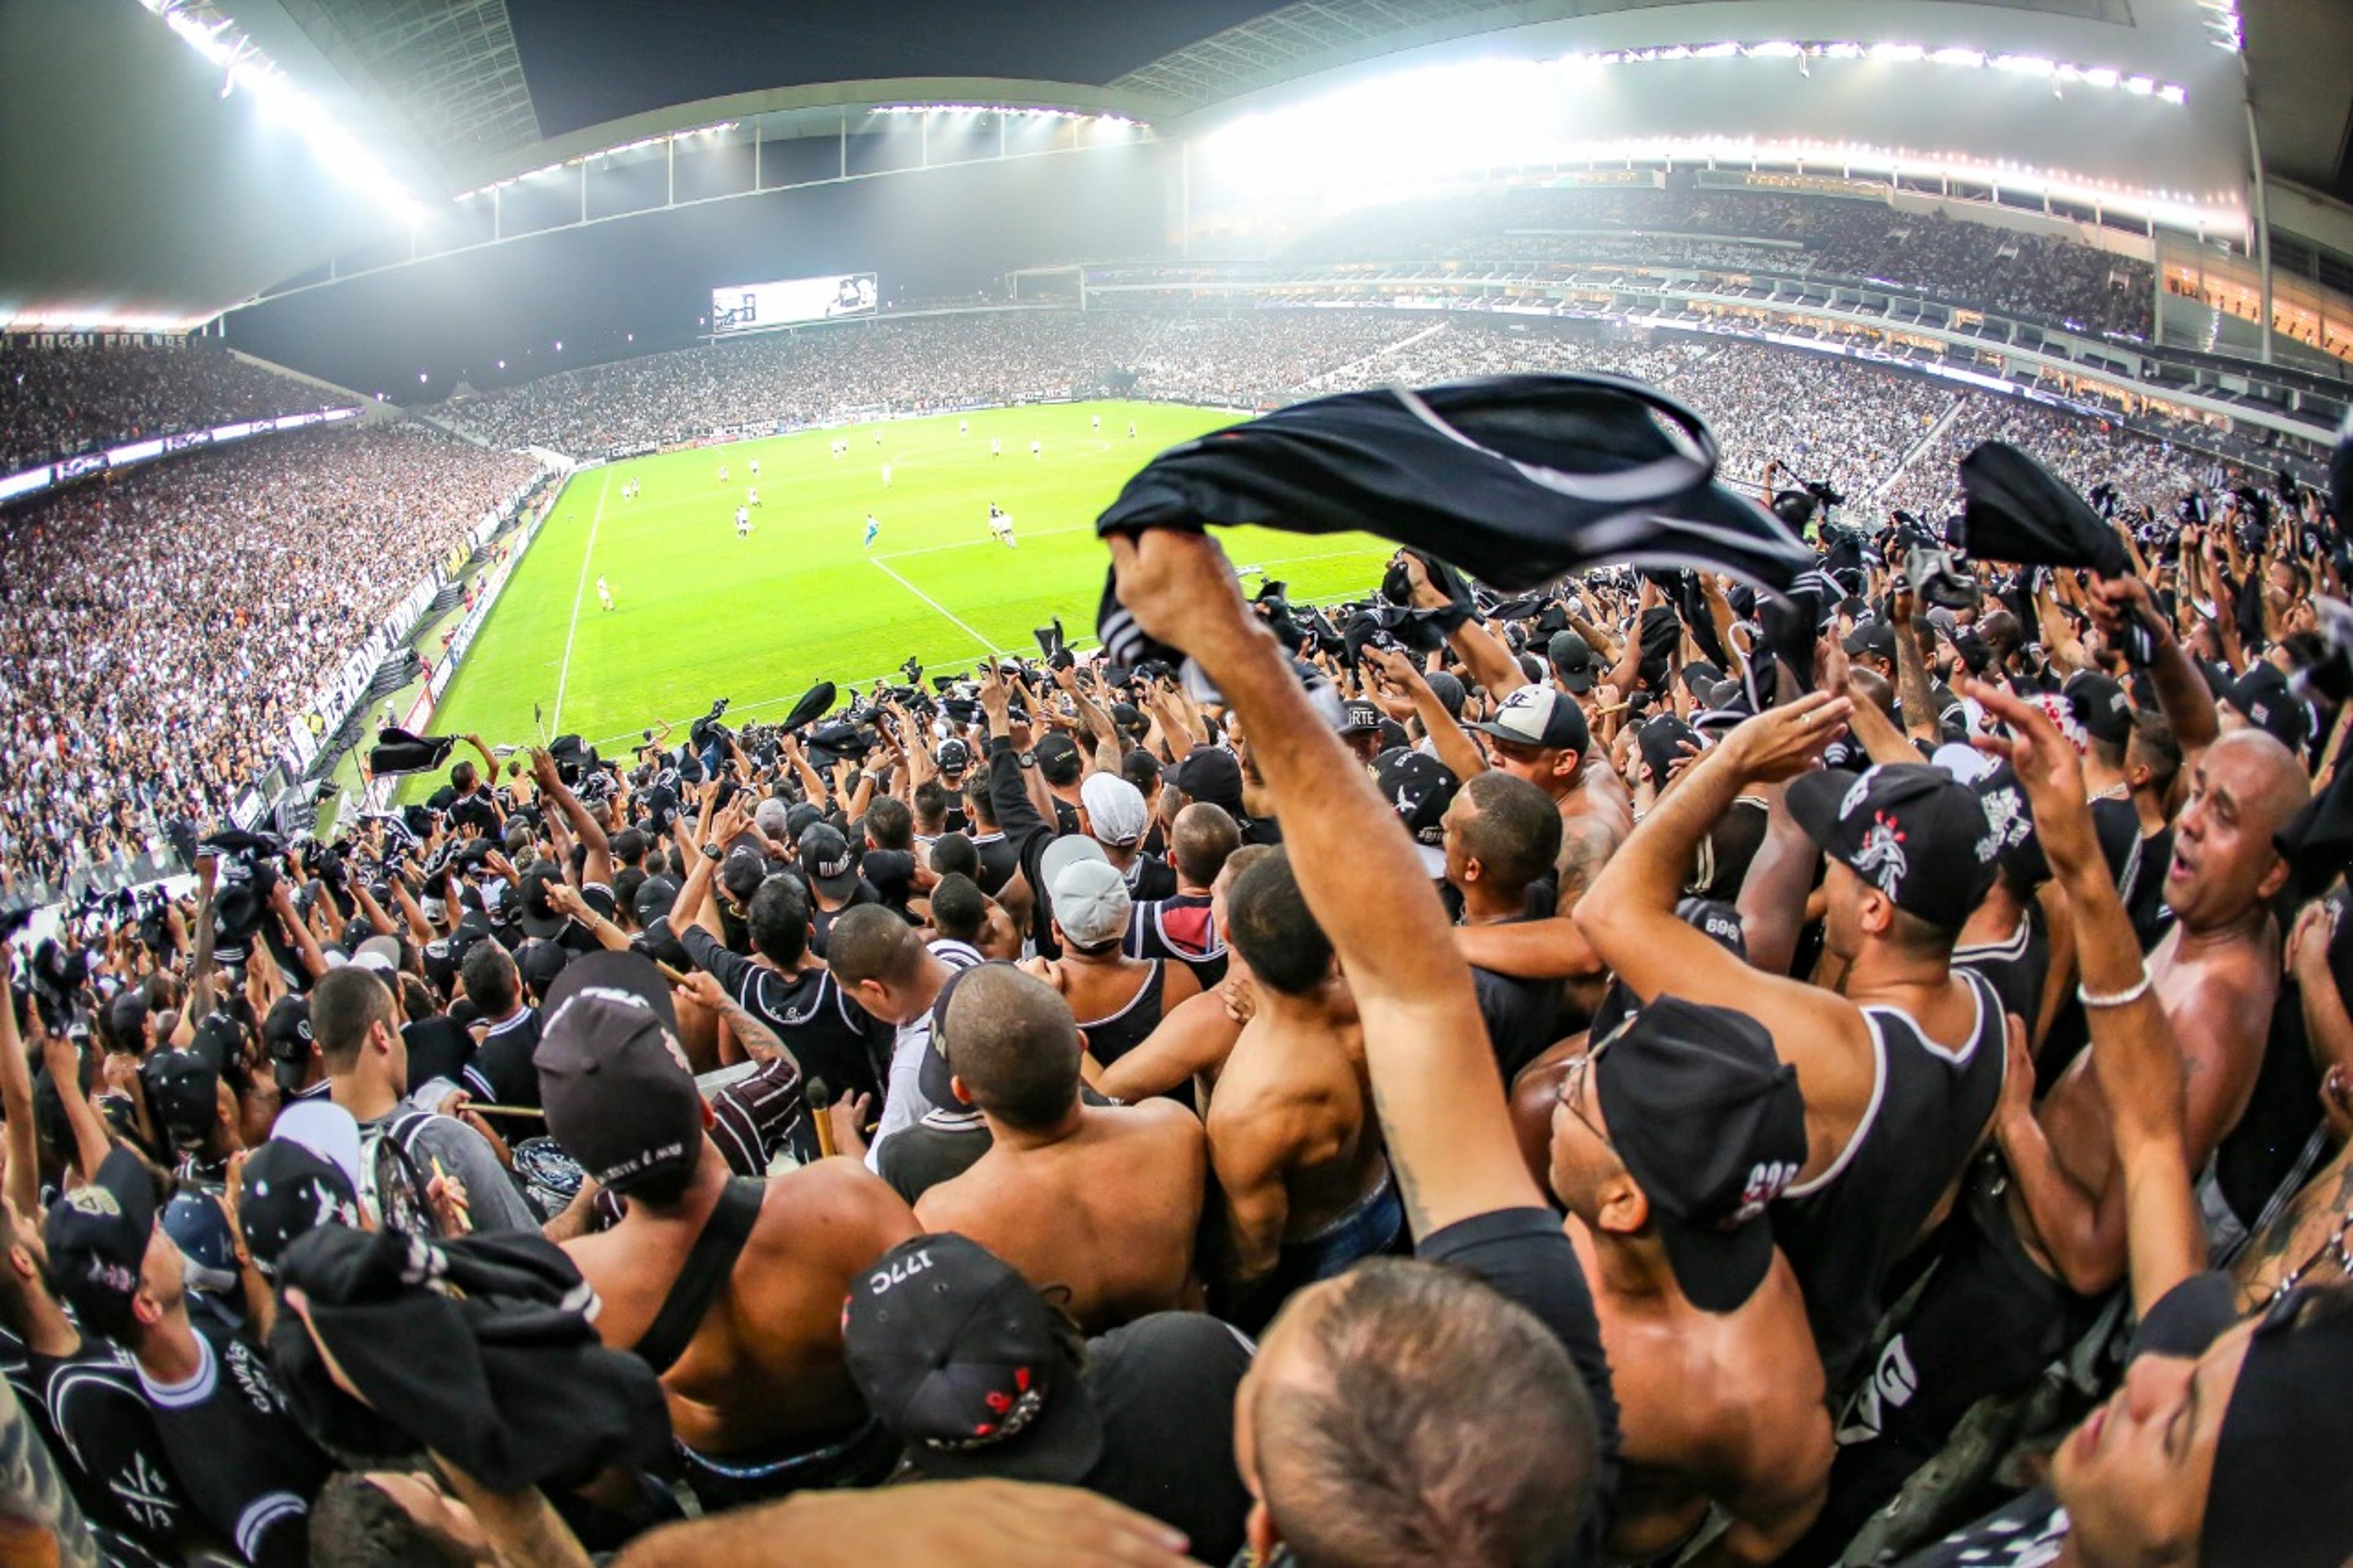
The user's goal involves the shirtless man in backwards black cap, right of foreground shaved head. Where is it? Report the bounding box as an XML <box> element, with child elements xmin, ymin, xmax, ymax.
<box><xmin>1551</xmin><ymin>996</ymin><xmax>1831</xmax><ymax>1563</ymax></box>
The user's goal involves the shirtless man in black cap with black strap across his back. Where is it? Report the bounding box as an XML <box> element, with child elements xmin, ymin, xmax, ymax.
<box><xmin>534</xmin><ymin>953</ymin><xmax>918</xmax><ymax>1512</ymax></box>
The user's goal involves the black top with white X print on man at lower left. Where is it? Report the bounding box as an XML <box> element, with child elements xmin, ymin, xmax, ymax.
<box><xmin>139</xmin><ymin>1325</ymin><xmax>334</xmax><ymax>1568</ymax></box>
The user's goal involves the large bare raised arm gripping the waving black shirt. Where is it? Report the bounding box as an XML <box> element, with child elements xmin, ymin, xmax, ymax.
<box><xmin>1108</xmin><ymin>530</ymin><xmax>1544</xmax><ymax>1236</ymax></box>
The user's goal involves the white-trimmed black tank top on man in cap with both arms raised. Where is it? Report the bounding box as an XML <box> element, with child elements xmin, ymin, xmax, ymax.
<box><xmin>1772</xmin><ymin>970</ymin><xmax>2009</xmax><ymax>1401</ymax></box>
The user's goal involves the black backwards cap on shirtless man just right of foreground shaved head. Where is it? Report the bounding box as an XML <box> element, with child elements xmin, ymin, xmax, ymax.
<box><xmin>1591</xmin><ymin>996</ymin><xmax>1807</xmax><ymax>1311</ymax></box>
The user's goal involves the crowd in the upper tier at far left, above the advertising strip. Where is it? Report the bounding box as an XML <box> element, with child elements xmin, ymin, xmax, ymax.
<box><xmin>0</xmin><ymin>339</ymin><xmax>332</xmax><ymax>473</ymax></box>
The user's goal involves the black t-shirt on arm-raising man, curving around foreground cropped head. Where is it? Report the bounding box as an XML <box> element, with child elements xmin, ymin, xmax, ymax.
<box><xmin>1414</xmin><ymin>1208</ymin><xmax>1619</xmax><ymax>1563</ymax></box>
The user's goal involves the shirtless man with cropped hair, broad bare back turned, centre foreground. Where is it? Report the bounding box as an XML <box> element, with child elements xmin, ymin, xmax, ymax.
<box><xmin>915</xmin><ymin>963</ymin><xmax>1210</xmax><ymax>1333</ymax></box>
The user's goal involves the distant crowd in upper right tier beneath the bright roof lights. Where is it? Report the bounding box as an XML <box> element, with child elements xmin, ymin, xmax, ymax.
<box><xmin>1283</xmin><ymin>188</ymin><xmax>2155</xmax><ymax>339</ymax></box>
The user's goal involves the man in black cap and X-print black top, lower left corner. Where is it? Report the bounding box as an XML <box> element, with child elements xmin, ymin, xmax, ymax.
<box><xmin>42</xmin><ymin>1144</ymin><xmax>329</xmax><ymax>1568</ymax></box>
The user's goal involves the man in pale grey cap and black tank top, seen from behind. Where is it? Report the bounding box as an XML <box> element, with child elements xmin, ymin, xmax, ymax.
<box><xmin>1023</xmin><ymin>838</ymin><xmax>1200</xmax><ymax>1067</ymax></box>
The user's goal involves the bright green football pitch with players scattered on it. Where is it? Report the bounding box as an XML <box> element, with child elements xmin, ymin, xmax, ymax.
<box><xmin>431</xmin><ymin>403</ymin><xmax>1389</xmax><ymax>754</ymax></box>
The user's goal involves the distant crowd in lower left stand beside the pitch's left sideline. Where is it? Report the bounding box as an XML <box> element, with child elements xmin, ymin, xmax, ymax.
<box><xmin>0</xmin><ymin>424</ymin><xmax>537</xmax><ymax>897</ymax></box>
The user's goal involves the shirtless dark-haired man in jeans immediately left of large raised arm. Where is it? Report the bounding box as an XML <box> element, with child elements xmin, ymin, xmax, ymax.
<box><xmin>1210</xmin><ymin>850</ymin><xmax>1404</xmax><ymax>1328</ymax></box>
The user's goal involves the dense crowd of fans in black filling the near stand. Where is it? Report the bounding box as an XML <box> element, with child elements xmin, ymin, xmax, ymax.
<box><xmin>0</xmin><ymin>353</ymin><xmax>2353</xmax><ymax>1568</ymax></box>
